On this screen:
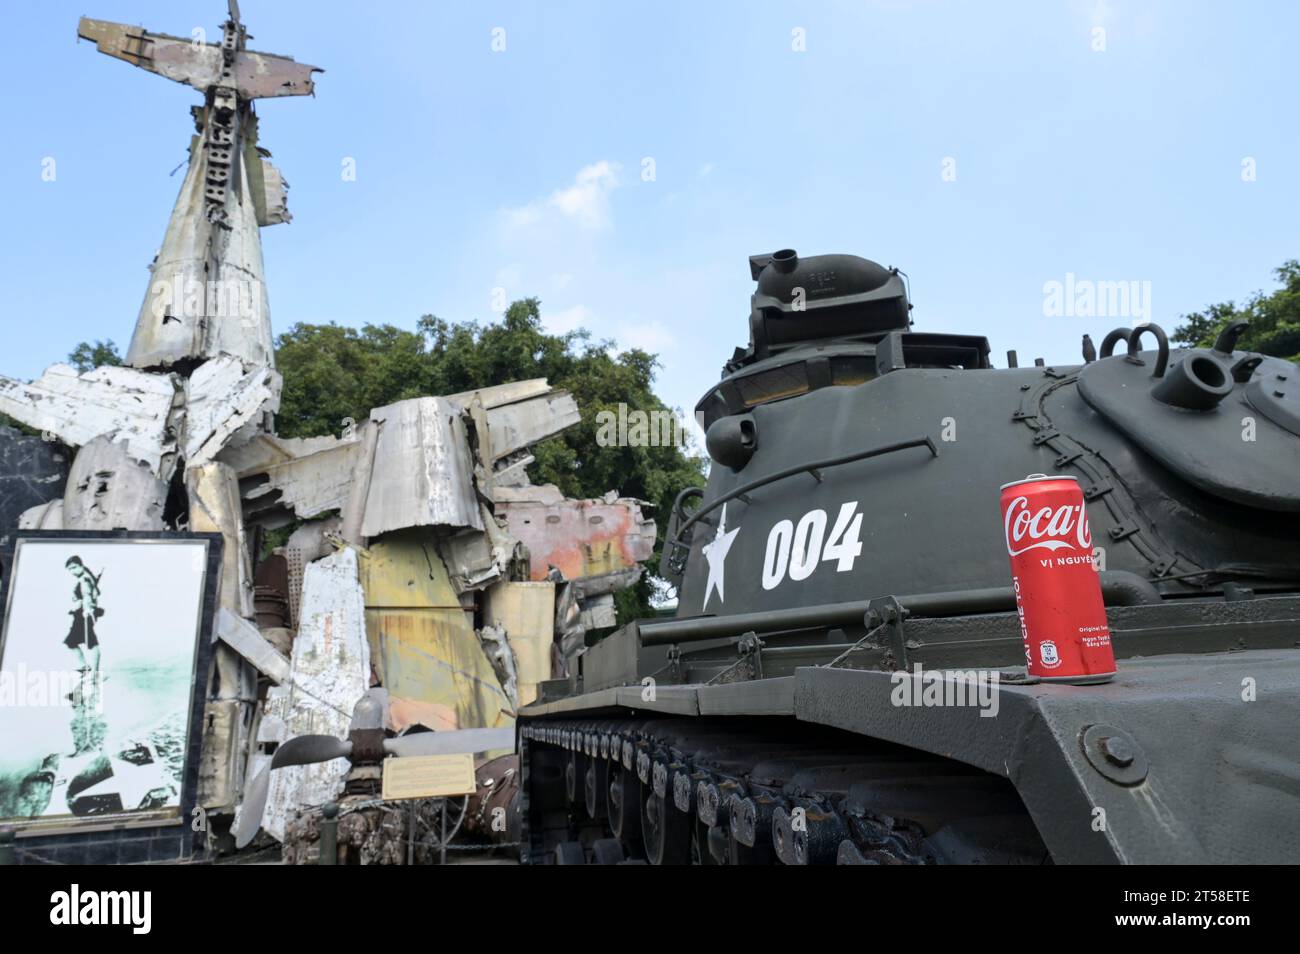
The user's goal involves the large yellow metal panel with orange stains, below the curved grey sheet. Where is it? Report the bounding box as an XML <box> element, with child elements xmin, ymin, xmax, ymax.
<box><xmin>361</xmin><ymin>530</ymin><xmax>514</xmax><ymax>730</ymax></box>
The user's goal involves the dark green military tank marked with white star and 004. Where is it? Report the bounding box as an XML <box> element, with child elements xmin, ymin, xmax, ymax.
<box><xmin>519</xmin><ymin>250</ymin><xmax>1300</xmax><ymax>864</ymax></box>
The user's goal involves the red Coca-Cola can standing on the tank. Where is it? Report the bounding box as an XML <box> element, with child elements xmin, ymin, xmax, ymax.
<box><xmin>1002</xmin><ymin>473</ymin><xmax>1115</xmax><ymax>685</ymax></box>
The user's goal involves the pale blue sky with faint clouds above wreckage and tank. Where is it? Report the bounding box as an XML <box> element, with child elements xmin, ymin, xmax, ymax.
<box><xmin>0</xmin><ymin>0</ymin><xmax>1300</xmax><ymax>426</ymax></box>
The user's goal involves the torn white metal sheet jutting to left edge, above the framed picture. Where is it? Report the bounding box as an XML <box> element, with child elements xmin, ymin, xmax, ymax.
<box><xmin>0</xmin><ymin>364</ymin><xmax>183</xmax><ymax>478</ymax></box>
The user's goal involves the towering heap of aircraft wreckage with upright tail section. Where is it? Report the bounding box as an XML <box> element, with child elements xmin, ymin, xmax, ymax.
<box><xmin>0</xmin><ymin>1</ymin><xmax>655</xmax><ymax>862</ymax></box>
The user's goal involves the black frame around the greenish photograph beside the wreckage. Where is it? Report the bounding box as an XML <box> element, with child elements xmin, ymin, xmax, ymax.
<box><xmin>0</xmin><ymin>530</ymin><xmax>224</xmax><ymax>864</ymax></box>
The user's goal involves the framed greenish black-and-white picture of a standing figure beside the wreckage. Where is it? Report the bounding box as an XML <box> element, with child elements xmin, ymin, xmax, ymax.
<box><xmin>0</xmin><ymin>532</ymin><xmax>221</xmax><ymax>837</ymax></box>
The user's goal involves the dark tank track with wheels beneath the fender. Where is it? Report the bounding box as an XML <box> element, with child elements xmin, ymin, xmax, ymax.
<box><xmin>520</xmin><ymin>716</ymin><xmax>1050</xmax><ymax>864</ymax></box>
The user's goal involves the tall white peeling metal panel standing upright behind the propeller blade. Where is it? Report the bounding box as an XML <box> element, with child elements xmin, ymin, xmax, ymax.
<box><xmin>259</xmin><ymin>548</ymin><xmax>371</xmax><ymax>841</ymax></box>
